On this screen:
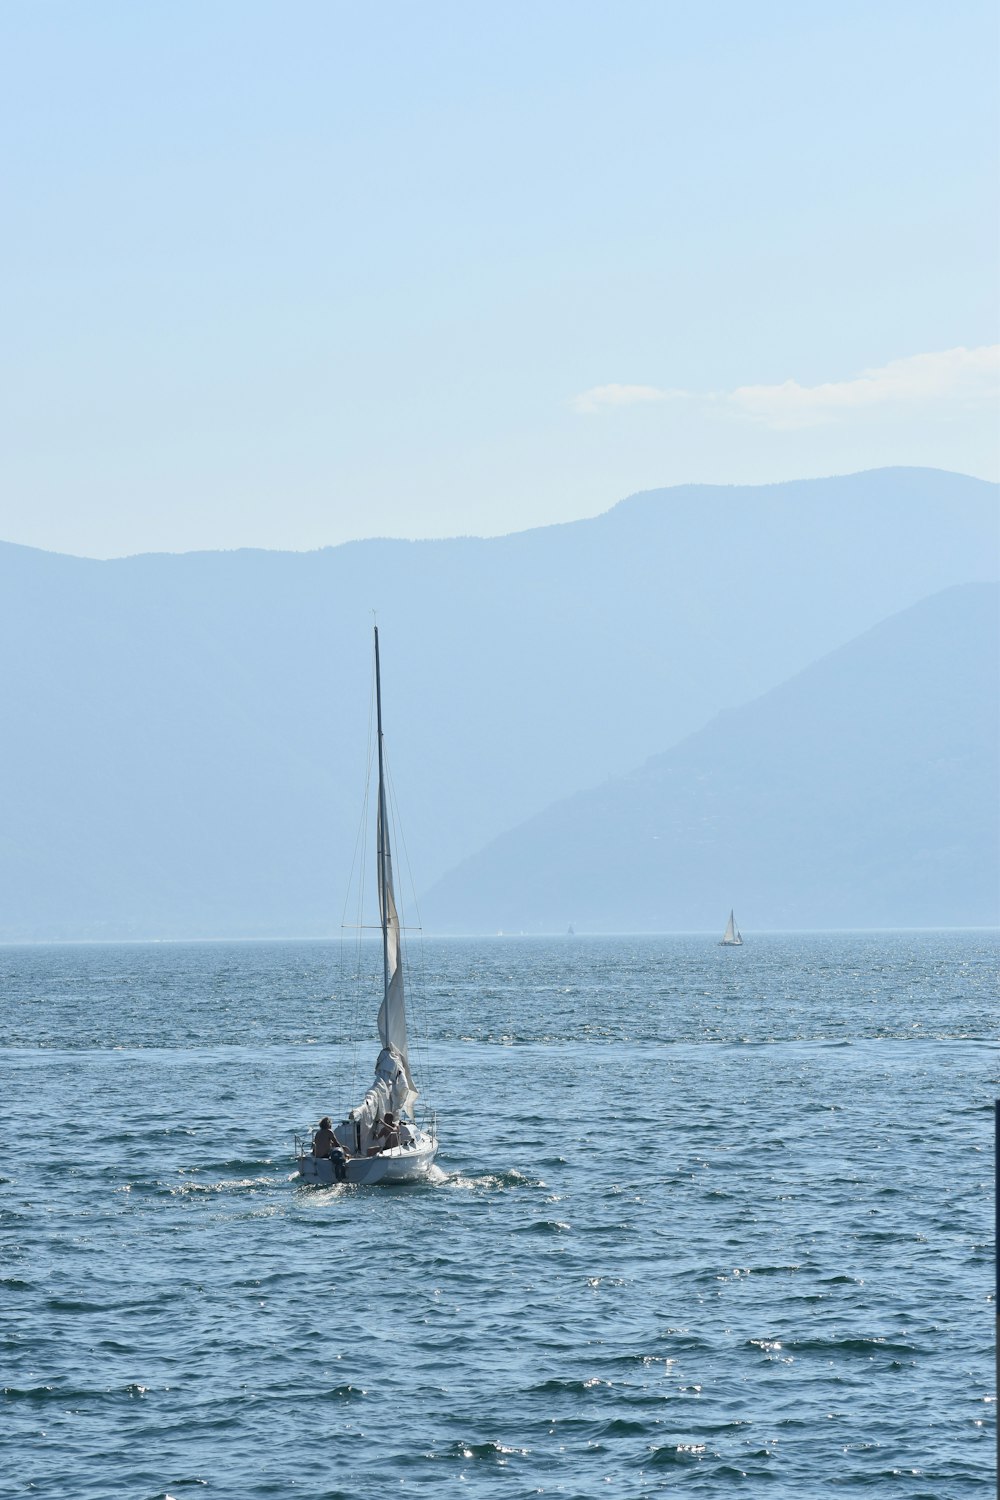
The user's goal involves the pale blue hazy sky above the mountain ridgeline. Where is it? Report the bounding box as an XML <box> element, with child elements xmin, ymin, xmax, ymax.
<box><xmin>0</xmin><ymin>0</ymin><xmax>1000</xmax><ymax>557</ymax></box>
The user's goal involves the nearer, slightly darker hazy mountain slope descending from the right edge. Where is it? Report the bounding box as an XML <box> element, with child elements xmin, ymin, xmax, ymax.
<box><xmin>423</xmin><ymin>584</ymin><xmax>1000</xmax><ymax>933</ymax></box>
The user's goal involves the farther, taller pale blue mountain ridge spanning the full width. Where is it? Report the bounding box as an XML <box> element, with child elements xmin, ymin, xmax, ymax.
<box><xmin>0</xmin><ymin>470</ymin><xmax>997</xmax><ymax>938</ymax></box>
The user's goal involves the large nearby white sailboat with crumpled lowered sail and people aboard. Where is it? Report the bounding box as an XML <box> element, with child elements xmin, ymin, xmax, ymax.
<box><xmin>295</xmin><ymin>626</ymin><xmax>438</xmax><ymax>1185</ymax></box>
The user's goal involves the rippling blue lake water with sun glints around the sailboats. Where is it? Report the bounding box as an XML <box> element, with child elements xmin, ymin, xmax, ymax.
<box><xmin>0</xmin><ymin>933</ymin><xmax>1000</xmax><ymax>1500</ymax></box>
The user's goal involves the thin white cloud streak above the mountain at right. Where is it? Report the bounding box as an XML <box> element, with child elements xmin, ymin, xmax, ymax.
<box><xmin>571</xmin><ymin>344</ymin><xmax>1000</xmax><ymax>431</ymax></box>
